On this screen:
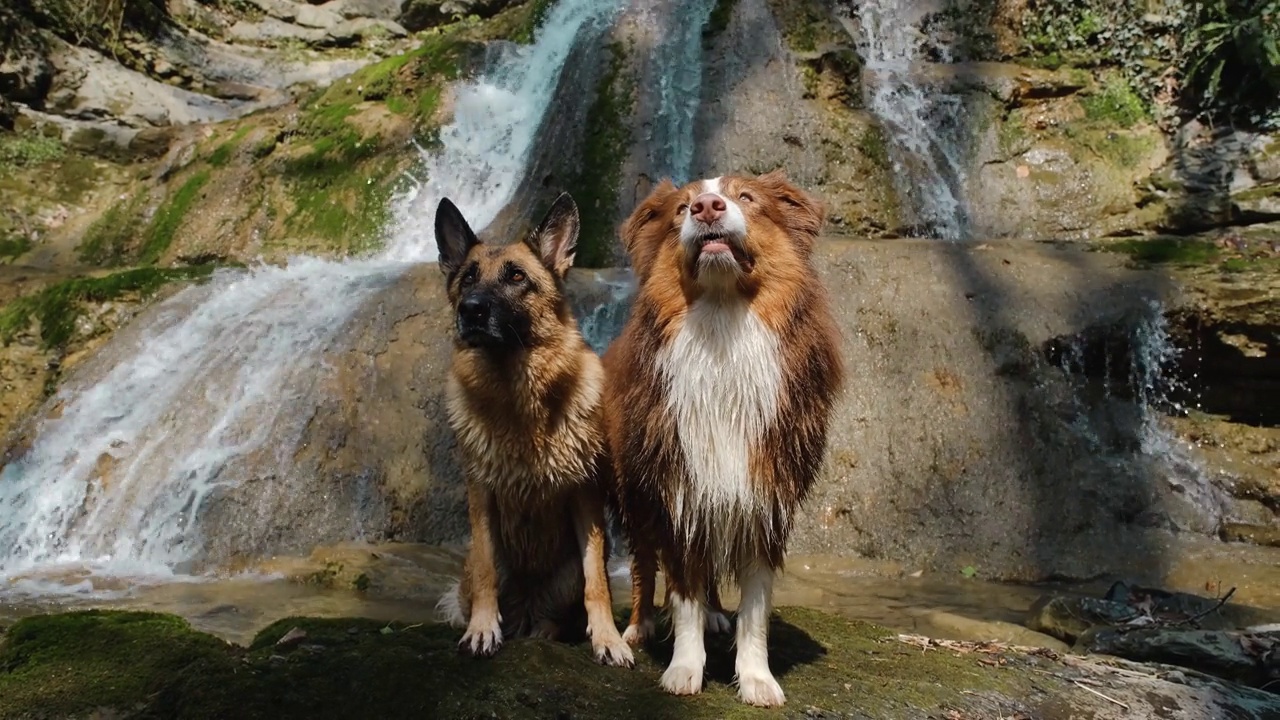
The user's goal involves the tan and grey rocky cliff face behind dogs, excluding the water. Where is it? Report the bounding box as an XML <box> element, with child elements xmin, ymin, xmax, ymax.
<box><xmin>0</xmin><ymin>0</ymin><xmax>1280</xmax><ymax>578</ymax></box>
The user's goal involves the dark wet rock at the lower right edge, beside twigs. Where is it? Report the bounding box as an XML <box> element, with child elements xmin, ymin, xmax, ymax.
<box><xmin>1078</xmin><ymin>628</ymin><xmax>1280</xmax><ymax>687</ymax></box>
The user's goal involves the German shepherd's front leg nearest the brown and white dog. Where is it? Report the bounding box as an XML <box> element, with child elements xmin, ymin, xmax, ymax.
<box><xmin>573</xmin><ymin>486</ymin><xmax>635</xmax><ymax>667</ymax></box>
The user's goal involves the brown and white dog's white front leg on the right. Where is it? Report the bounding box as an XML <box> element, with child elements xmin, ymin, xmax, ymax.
<box><xmin>735</xmin><ymin>553</ymin><xmax>786</xmax><ymax>707</ymax></box>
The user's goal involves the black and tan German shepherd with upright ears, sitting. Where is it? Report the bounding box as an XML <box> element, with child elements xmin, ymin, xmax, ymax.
<box><xmin>435</xmin><ymin>193</ymin><xmax>635</xmax><ymax>666</ymax></box>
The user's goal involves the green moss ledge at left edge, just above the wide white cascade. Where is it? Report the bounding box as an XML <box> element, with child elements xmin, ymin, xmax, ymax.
<box><xmin>0</xmin><ymin>265</ymin><xmax>212</xmax><ymax>348</ymax></box>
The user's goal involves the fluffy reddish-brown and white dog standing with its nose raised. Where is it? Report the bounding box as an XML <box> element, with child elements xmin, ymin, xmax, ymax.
<box><xmin>604</xmin><ymin>172</ymin><xmax>842</xmax><ymax>706</ymax></box>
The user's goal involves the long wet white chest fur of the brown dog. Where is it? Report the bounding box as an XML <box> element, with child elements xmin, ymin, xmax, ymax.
<box><xmin>658</xmin><ymin>299</ymin><xmax>782</xmax><ymax>550</ymax></box>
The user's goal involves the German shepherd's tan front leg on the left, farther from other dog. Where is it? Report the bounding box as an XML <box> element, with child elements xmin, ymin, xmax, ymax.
<box><xmin>458</xmin><ymin>483</ymin><xmax>502</xmax><ymax>656</ymax></box>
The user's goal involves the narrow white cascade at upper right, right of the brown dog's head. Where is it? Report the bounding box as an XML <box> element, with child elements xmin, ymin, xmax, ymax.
<box><xmin>858</xmin><ymin>0</ymin><xmax>969</xmax><ymax>240</ymax></box>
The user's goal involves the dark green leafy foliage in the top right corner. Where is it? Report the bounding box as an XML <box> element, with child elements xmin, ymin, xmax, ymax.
<box><xmin>1184</xmin><ymin>0</ymin><xmax>1280</xmax><ymax>124</ymax></box>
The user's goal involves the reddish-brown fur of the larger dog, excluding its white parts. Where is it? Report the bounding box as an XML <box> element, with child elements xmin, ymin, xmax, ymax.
<box><xmin>604</xmin><ymin>172</ymin><xmax>842</xmax><ymax>642</ymax></box>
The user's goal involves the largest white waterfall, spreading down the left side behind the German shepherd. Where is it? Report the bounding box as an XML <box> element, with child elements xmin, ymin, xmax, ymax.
<box><xmin>0</xmin><ymin>0</ymin><xmax>621</xmax><ymax>592</ymax></box>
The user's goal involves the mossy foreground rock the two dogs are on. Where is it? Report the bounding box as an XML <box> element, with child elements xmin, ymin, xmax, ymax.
<box><xmin>0</xmin><ymin>609</ymin><xmax>1280</xmax><ymax>720</ymax></box>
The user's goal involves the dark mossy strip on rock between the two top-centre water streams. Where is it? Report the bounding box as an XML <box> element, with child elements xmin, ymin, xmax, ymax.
<box><xmin>571</xmin><ymin>37</ymin><xmax>635</xmax><ymax>268</ymax></box>
